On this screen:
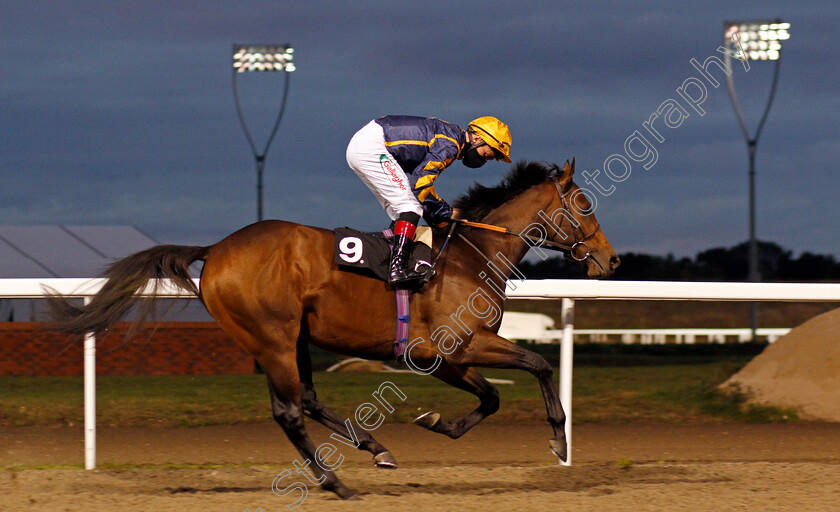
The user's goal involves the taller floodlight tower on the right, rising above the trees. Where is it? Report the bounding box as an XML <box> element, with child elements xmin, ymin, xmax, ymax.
<box><xmin>723</xmin><ymin>19</ymin><xmax>790</xmax><ymax>341</ymax></box>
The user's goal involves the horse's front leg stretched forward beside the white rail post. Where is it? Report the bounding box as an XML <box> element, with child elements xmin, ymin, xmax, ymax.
<box><xmin>447</xmin><ymin>329</ymin><xmax>567</xmax><ymax>462</ymax></box>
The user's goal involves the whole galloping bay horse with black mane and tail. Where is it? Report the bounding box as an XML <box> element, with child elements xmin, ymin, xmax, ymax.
<box><xmin>48</xmin><ymin>161</ymin><xmax>619</xmax><ymax>498</ymax></box>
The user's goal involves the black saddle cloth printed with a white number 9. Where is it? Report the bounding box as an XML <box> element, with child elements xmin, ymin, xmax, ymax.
<box><xmin>335</xmin><ymin>227</ymin><xmax>432</xmax><ymax>282</ymax></box>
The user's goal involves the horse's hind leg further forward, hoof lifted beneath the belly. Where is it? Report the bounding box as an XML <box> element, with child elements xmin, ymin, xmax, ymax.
<box><xmin>297</xmin><ymin>338</ymin><xmax>397</xmax><ymax>469</ymax></box>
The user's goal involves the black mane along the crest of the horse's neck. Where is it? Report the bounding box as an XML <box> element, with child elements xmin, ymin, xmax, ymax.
<box><xmin>452</xmin><ymin>161</ymin><xmax>561</xmax><ymax>221</ymax></box>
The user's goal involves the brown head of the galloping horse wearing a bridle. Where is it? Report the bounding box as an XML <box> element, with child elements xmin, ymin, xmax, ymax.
<box><xmin>538</xmin><ymin>158</ymin><xmax>621</xmax><ymax>278</ymax></box>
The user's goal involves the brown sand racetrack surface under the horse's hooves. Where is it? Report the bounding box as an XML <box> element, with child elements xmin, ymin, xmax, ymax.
<box><xmin>0</xmin><ymin>424</ymin><xmax>840</xmax><ymax>512</ymax></box>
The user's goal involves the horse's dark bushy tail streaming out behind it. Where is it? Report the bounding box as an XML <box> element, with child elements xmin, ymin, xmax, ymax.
<box><xmin>47</xmin><ymin>245</ymin><xmax>210</xmax><ymax>340</ymax></box>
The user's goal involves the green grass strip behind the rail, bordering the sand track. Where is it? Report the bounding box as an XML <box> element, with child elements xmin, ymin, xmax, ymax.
<box><xmin>0</xmin><ymin>359</ymin><xmax>797</xmax><ymax>427</ymax></box>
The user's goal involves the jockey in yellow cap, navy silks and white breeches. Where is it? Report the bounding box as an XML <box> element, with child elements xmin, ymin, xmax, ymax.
<box><xmin>347</xmin><ymin>116</ymin><xmax>511</xmax><ymax>285</ymax></box>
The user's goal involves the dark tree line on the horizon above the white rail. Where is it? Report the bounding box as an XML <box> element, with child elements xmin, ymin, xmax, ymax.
<box><xmin>519</xmin><ymin>241</ymin><xmax>840</xmax><ymax>282</ymax></box>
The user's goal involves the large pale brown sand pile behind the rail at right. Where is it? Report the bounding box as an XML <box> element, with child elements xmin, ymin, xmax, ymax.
<box><xmin>721</xmin><ymin>309</ymin><xmax>840</xmax><ymax>421</ymax></box>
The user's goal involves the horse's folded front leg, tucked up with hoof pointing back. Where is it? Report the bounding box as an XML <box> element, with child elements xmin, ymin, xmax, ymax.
<box><xmin>414</xmin><ymin>363</ymin><xmax>499</xmax><ymax>439</ymax></box>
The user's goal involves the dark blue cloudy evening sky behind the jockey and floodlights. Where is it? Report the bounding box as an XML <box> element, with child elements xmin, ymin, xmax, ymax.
<box><xmin>0</xmin><ymin>0</ymin><xmax>840</xmax><ymax>255</ymax></box>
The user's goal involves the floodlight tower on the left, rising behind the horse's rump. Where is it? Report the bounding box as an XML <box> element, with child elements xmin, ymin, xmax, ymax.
<box><xmin>233</xmin><ymin>44</ymin><xmax>295</xmax><ymax>221</ymax></box>
